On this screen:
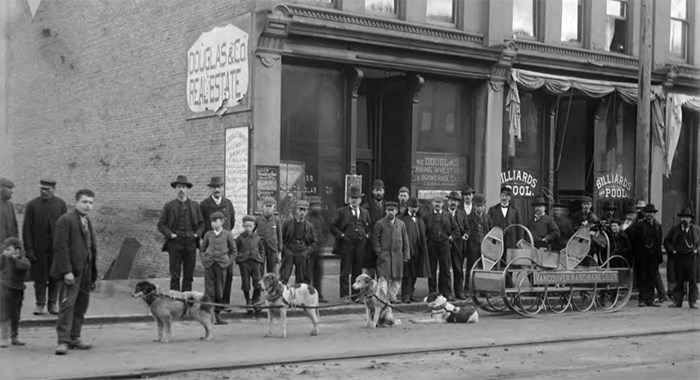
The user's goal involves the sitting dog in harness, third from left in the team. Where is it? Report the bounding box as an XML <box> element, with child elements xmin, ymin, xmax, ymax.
<box><xmin>352</xmin><ymin>274</ymin><xmax>401</xmax><ymax>329</ymax></box>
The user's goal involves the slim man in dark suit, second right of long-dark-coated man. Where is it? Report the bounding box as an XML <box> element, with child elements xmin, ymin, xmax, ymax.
<box><xmin>447</xmin><ymin>191</ymin><xmax>471</xmax><ymax>300</ymax></box>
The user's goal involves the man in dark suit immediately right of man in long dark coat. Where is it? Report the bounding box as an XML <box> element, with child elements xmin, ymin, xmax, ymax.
<box><xmin>423</xmin><ymin>195</ymin><xmax>460</xmax><ymax>302</ymax></box>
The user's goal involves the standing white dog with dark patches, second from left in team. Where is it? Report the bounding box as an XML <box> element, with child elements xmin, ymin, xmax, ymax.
<box><xmin>260</xmin><ymin>273</ymin><xmax>319</xmax><ymax>338</ymax></box>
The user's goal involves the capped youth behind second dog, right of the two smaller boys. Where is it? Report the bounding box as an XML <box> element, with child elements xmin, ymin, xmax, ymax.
<box><xmin>255</xmin><ymin>197</ymin><xmax>282</xmax><ymax>273</ymax></box>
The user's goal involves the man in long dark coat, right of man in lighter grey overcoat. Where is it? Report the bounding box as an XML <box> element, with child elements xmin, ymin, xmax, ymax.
<box><xmin>399</xmin><ymin>197</ymin><xmax>430</xmax><ymax>303</ymax></box>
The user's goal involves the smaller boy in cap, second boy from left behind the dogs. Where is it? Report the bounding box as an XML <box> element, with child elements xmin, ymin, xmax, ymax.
<box><xmin>236</xmin><ymin>215</ymin><xmax>265</xmax><ymax>314</ymax></box>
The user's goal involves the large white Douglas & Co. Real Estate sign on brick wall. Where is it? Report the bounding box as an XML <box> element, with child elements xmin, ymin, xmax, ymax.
<box><xmin>187</xmin><ymin>24</ymin><xmax>249</xmax><ymax>113</ymax></box>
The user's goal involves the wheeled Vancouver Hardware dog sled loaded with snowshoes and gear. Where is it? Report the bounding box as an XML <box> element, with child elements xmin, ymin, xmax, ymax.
<box><xmin>469</xmin><ymin>224</ymin><xmax>632</xmax><ymax>317</ymax></box>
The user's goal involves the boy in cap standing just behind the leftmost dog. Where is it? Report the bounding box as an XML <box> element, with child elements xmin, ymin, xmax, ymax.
<box><xmin>200</xmin><ymin>211</ymin><xmax>237</xmax><ymax>325</ymax></box>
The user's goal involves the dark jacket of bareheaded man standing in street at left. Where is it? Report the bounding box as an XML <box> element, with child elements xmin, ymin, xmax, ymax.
<box><xmin>51</xmin><ymin>211</ymin><xmax>97</xmax><ymax>282</ymax></box>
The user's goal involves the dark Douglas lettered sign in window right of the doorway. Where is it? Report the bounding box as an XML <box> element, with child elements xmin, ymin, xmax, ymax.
<box><xmin>411</xmin><ymin>152</ymin><xmax>467</xmax><ymax>190</ymax></box>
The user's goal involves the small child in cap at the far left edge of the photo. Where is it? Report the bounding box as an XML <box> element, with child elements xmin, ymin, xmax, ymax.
<box><xmin>0</xmin><ymin>237</ymin><xmax>31</xmax><ymax>347</ymax></box>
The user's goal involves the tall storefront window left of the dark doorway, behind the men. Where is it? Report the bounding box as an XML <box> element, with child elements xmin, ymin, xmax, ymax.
<box><xmin>279</xmin><ymin>65</ymin><xmax>345</xmax><ymax>248</ymax></box>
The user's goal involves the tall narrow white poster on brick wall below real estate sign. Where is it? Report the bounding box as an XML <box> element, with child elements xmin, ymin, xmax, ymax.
<box><xmin>224</xmin><ymin>126</ymin><xmax>249</xmax><ymax>234</ymax></box>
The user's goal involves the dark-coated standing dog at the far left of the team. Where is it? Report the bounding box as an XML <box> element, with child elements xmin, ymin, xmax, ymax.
<box><xmin>131</xmin><ymin>281</ymin><xmax>214</xmax><ymax>343</ymax></box>
